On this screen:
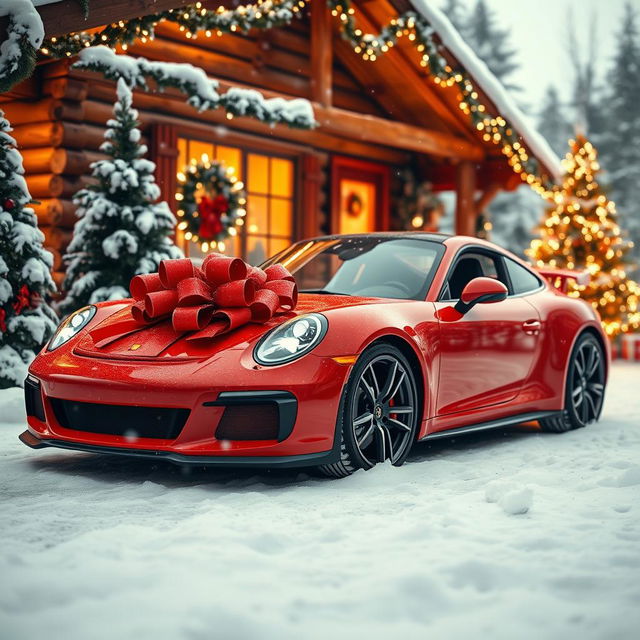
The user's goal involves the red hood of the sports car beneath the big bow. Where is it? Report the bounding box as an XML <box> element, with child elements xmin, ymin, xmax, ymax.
<box><xmin>74</xmin><ymin>293</ymin><xmax>383</xmax><ymax>361</ymax></box>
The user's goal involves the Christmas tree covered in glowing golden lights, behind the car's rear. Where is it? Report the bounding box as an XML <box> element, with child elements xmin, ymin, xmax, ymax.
<box><xmin>529</xmin><ymin>135</ymin><xmax>640</xmax><ymax>336</ymax></box>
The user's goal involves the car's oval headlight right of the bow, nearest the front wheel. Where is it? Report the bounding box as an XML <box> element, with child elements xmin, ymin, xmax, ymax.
<box><xmin>253</xmin><ymin>313</ymin><xmax>328</xmax><ymax>365</ymax></box>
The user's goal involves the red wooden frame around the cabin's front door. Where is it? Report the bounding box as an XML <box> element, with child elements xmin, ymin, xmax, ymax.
<box><xmin>330</xmin><ymin>155</ymin><xmax>390</xmax><ymax>233</ymax></box>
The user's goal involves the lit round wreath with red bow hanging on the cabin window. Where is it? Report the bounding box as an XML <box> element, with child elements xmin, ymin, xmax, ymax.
<box><xmin>176</xmin><ymin>157</ymin><xmax>247</xmax><ymax>253</ymax></box>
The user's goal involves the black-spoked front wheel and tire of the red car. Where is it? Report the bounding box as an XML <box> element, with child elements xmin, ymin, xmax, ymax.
<box><xmin>319</xmin><ymin>343</ymin><xmax>420</xmax><ymax>478</ymax></box>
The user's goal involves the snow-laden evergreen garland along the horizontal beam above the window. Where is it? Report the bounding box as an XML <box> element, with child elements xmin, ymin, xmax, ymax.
<box><xmin>74</xmin><ymin>46</ymin><xmax>316</xmax><ymax>129</ymax></box>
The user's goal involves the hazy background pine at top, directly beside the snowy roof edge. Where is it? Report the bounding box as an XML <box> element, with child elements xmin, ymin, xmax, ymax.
<box><xmin>464</xmin><ymin>0</ymin><xmax>519</xmax><ymax>91</ymax></box>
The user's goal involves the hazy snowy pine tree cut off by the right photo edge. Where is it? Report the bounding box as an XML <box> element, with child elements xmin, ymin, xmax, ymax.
<box><xmin>600</xmin><ymin>4</ymin><xmax>640</xmax><ymax>268</ymax></box>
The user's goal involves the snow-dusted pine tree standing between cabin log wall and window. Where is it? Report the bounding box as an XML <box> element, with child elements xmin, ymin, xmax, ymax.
<box><xmin>60</xmin><ymin>78</ymin><xmax>182</xmax><ymax>312</ymax></box>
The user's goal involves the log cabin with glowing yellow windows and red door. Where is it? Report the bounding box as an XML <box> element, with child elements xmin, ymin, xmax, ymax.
<box><xmin>0</xmin><ymin>0</ymin><xmax>559</xmax><ymax>281</ymax></box>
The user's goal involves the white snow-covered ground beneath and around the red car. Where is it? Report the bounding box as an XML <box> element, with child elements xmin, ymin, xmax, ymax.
<box><xmin>0</xmin><ymin>363</ymin><xmax>640</xmax><ymax>640</ymax></box>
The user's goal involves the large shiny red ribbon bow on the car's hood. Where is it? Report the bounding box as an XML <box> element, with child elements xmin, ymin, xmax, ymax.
<box><xmin>130</xmin><ymin>253</ymin><xmax>298</xmax><ymax>340</ymax></box>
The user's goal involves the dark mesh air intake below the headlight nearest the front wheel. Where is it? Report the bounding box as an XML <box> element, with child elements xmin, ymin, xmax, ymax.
<box><xmin>216</xmin><ymin>402</ymin><xmax>280</xmax><ymax>440</ymax></box>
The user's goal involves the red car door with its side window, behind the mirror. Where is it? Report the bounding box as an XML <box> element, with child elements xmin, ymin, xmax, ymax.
<box><xmin>436</xmin><ymin>247</ymin><xmax>542</xmax><ymax>415</ymax></box>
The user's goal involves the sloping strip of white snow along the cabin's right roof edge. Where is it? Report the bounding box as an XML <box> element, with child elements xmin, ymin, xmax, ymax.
<box><xmin>411</xmin><ymin>0</ymin><xmax>562</xmax><ymax>180</ymax></box>
